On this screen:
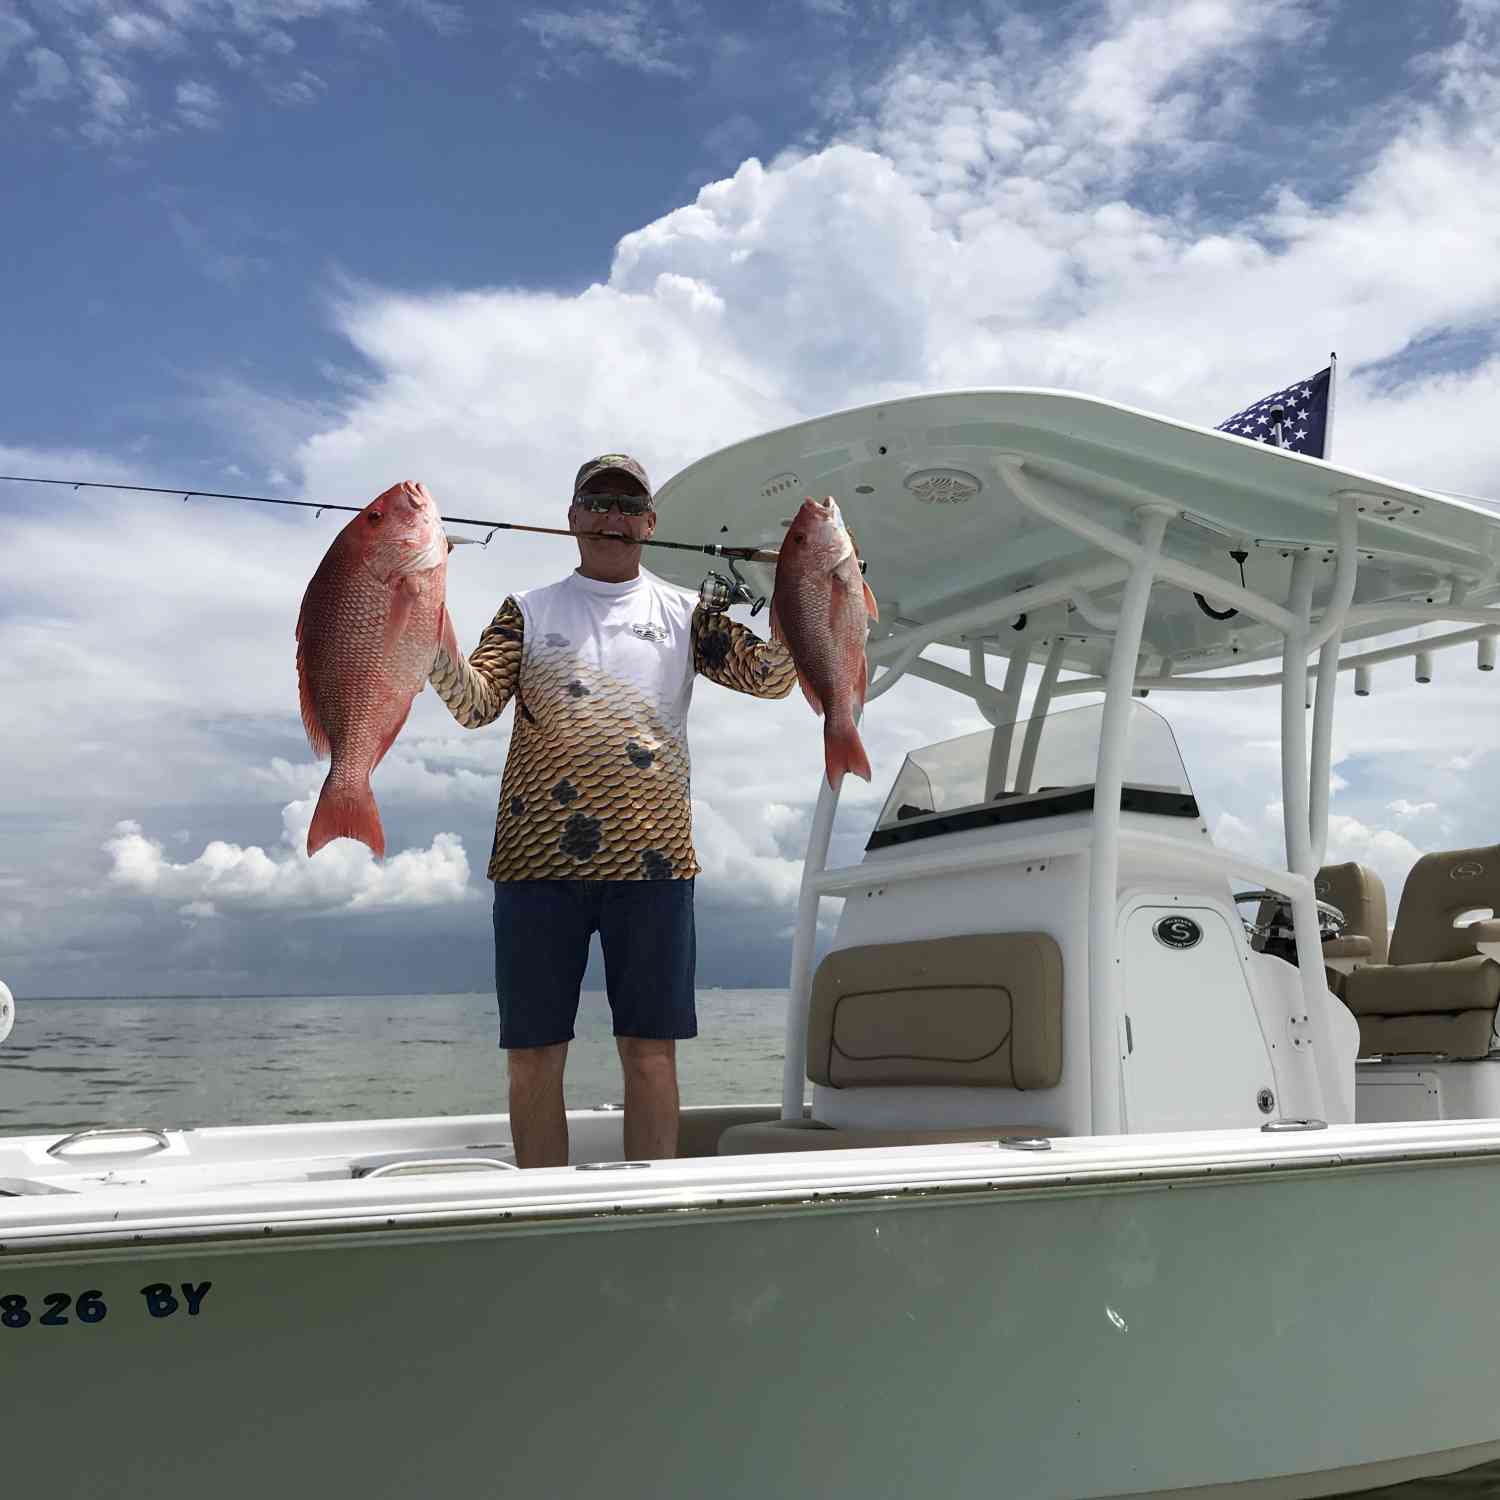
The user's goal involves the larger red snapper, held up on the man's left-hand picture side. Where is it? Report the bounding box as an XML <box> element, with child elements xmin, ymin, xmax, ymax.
<box><xmin>297</xmin><ymin>482</ymin><xmax>459</xmax><ymax>855</ymax></box>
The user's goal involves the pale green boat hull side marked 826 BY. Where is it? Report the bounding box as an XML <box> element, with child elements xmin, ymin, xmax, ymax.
<box><xmin>0</xmin><ymin>1155</ymin><xmax>1500</xmax><ymax>1500</ymax></box>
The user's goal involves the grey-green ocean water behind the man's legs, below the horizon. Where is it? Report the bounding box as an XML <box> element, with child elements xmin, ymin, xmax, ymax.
<box><xmin>0</xmin><ymin>990</ymin><xmax>786</xmax><ymax>1134</ymax></box>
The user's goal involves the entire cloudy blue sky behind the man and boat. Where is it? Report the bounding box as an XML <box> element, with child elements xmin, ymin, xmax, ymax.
<box><xmin>0</xmin><ymin>0</ymin><xmax>1500</xmax><ymax>993</ymax></box>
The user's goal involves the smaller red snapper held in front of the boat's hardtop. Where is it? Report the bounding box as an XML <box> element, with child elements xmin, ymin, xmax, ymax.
<box><xmin>771</xmin><ymin>495</ymin><xmax>881</xmax><ymax>791</ymax></box>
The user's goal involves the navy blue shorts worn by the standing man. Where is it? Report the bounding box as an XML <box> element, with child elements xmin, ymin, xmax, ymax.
<box><xmin>495</xmin><ymin>881</ymin><xmax>698</xmax><ymax>1047</ymax></box>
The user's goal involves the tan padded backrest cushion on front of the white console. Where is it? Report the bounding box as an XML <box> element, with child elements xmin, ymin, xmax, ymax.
<box><xmin>807</xmin><ymin>933</ymin><xmax>1062</xmax><ymax>1089</ymax></box>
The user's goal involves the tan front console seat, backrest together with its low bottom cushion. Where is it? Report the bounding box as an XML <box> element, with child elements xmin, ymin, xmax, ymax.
<box><xmin>719</xmin><ymin>933</ymin><xmax>1062</xmax><ymax>1155</ymax></box>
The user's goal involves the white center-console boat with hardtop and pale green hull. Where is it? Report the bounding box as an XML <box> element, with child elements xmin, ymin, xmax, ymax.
<box><xmin>0</xmin><ymin>390</ymin><xmax>1500</xmax><ymax>1500</ymax></box>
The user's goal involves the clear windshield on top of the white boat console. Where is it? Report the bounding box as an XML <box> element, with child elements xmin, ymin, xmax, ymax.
<box><xmin>876</xmin><ymin>701</ymin><xmax>1197</xmax><ymax>843</ymax></box>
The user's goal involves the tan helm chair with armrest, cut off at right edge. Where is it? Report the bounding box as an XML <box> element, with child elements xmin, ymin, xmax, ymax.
<box><xmin>1343</xmin><ymin>845</ymin><xmax>1500</xmax><ymax>1058</ymax></box>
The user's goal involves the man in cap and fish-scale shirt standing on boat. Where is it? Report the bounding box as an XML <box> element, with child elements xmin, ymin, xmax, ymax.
<box><xmin>431</xmin><ymin>453</ymin><xmax>797</xmax><ymax>1167</ymax></box>
